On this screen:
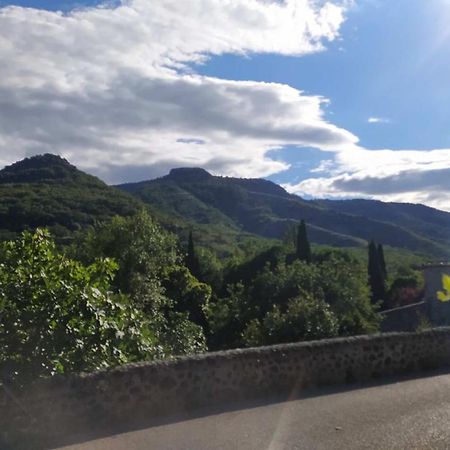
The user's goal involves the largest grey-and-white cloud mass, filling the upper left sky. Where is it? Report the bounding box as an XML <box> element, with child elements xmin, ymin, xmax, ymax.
<box><xmin>0</xmin><ymin>0</ymin><xmax>357</xmax><ymax>182</ymax></box>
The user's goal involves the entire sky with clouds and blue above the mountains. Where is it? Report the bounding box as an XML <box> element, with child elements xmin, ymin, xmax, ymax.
<box><xmin>0</xmin><ymin>0</ymin><xmax>450</xmax><ymax>211</ymax></box>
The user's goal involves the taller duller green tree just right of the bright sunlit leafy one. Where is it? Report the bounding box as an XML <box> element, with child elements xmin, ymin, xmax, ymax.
<box><xmin>73</xmin><ymin>210</ymin><xmax>210</xmax><ymax>356</ymax></box>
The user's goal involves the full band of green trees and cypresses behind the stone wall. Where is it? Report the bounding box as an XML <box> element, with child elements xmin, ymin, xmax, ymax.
<box><xmin>0</xmin><ymin>210</ymin><xmax>422</xmax><ymax>383</ymax></box>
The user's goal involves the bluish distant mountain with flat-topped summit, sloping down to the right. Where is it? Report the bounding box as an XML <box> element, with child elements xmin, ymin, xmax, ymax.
<box><xmin>117</xmin><ymin>168</ymin><xmax>450</xmax><ymax>258</ymax></box>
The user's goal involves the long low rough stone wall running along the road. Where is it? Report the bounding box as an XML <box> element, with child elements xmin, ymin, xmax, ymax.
<box><xmin>0</xmin><ymin>328</ymin><xmax>450</xmax><ymax>448</ymax></box>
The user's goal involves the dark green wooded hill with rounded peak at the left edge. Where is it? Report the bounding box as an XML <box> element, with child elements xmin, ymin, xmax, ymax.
<box><xmin>0</xmin><ymin>154</ymin><xmax>142</xmax><ymax>238</ymax></box>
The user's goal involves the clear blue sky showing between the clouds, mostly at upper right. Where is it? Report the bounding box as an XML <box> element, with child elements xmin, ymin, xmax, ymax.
<box><xmin>197</xmin><ymin>0</ymin><xmax>450</xmax><ymax>182</ymax></box>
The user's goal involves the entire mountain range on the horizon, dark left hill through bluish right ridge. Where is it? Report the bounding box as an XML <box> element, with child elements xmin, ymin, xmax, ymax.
<box><xmin>0</xmin><ymin>154</ymin><xmax>450</xmax><ymax>258</ymax></box>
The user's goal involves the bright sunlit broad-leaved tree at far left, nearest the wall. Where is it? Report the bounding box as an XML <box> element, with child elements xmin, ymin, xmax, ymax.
<box><xmin>0</xmin><ymin>230</ymin><xmax>160</xmax><ymax>382</ymax></box>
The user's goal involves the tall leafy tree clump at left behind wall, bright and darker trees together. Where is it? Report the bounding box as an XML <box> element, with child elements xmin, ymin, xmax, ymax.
<box><xmin>0</xmin><ymin>211</ymin><xmax>211</xmax><ymax>382</ymax></box>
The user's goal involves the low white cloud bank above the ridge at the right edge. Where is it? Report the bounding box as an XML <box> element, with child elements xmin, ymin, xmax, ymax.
<box><xmin>285</xmin><ymin>147</ymin><xmax>450</xmax><ymax>211</ymax></box>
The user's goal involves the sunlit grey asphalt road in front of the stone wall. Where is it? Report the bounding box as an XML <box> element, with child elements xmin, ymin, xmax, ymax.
<box><xmin>59</xmin><ymin>375</ymin><xmax>450</xmax><ymax>450</ymax></box>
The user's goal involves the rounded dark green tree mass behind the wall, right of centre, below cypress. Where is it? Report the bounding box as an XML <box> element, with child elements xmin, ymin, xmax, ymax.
<box><xmin>209</xmin><ymin>247</ymin><xmax>379</xmax><ymax>348</ymax></box>
